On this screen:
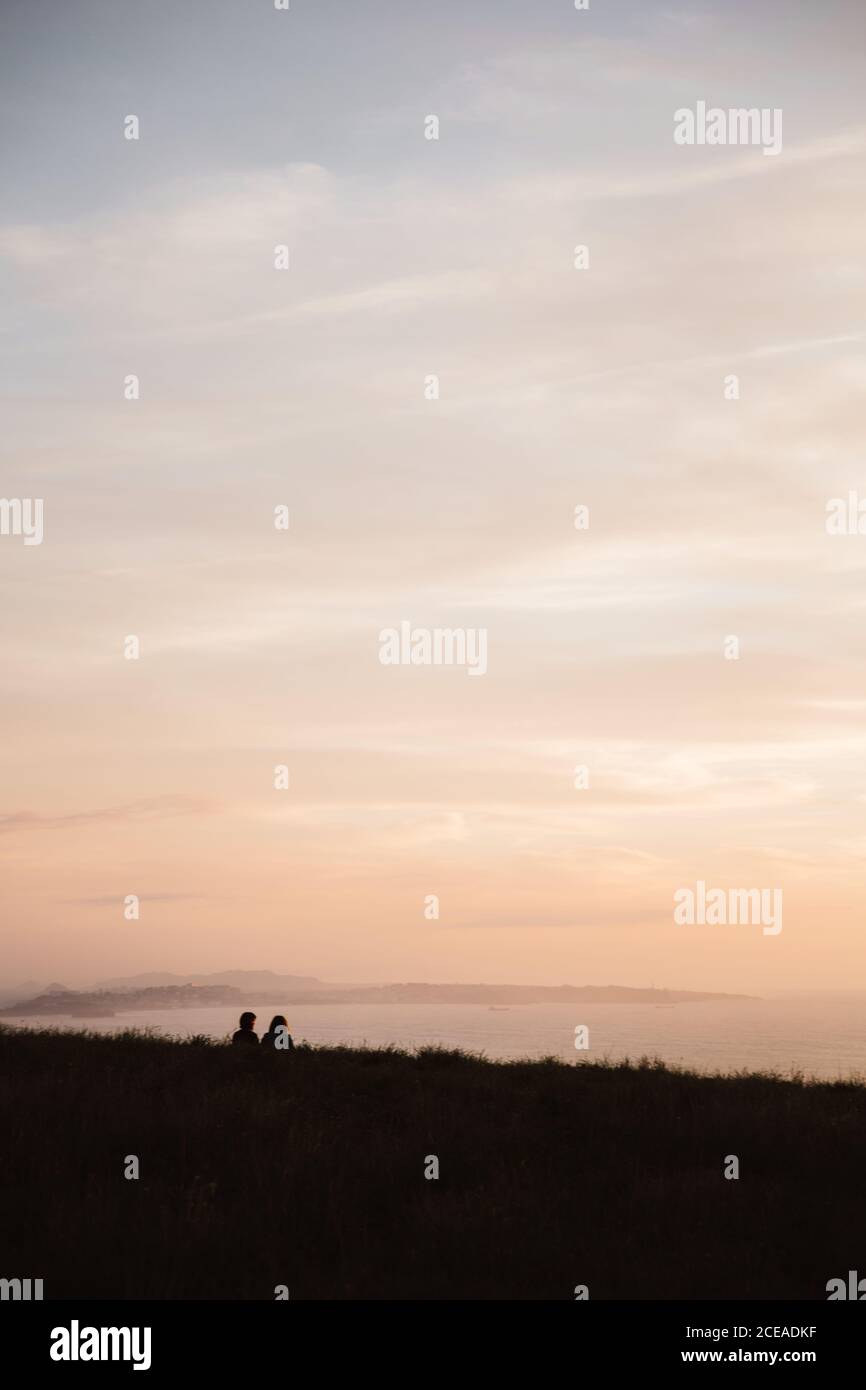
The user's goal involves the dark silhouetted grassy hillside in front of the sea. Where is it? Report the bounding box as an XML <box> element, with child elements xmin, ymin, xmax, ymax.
<box><xmin>0</xmin><ymin>1029</ymin><xmax>866</xmax><ymax>1300</ymax></box>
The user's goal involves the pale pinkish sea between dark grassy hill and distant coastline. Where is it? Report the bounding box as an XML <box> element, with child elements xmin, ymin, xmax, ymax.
<box><xmin>4</xmin><ymin>998</ymin><xmax>866</xmax><ymax>1080</ymax></box>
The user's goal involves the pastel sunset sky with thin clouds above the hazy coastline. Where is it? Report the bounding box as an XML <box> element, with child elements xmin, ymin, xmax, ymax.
<box><xmin>0</xmin><ymin>0</ymin><xmax>866</xmax><ymax>994</ymax></box>
